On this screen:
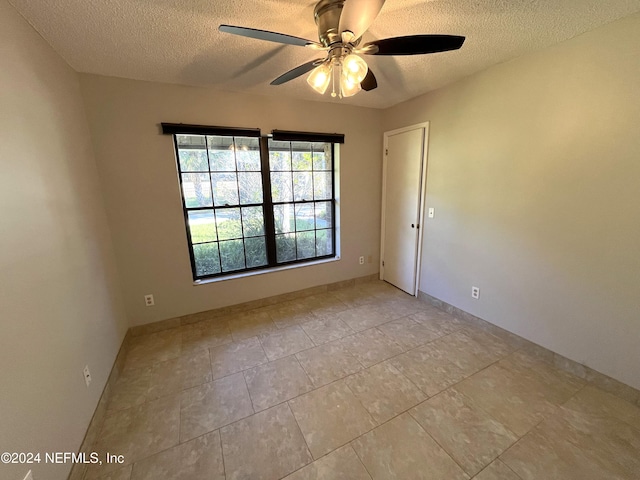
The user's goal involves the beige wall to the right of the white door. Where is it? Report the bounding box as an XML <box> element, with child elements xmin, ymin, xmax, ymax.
<box><xmin>384</xmin><ymin>15</ymin><xmax>640</xmax><ymax>388</ymax></box>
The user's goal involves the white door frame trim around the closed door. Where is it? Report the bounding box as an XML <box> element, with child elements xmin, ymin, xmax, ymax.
<box><xmin>379</xmin><ymin>122</ymin><xmax>429</xmax><ymax>297</ymax></box>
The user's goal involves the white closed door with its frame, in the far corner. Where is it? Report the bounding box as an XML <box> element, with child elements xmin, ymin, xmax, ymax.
<box><xmin>380</xmin><ymin>124</ymin><xmax>427</xmax><ymax>295</ymax></box>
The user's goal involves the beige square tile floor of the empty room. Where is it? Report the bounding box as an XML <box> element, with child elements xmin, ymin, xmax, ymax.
<box><xmin>85</xmin><ymin>282</ymin><xmax>640</xmax><ymax>480</ymax></box>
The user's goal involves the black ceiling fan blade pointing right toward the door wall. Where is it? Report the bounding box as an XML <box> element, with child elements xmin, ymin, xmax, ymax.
<box><xmin>362</xmin><ymin>35</ymin><xmax>465</xmax><ymax>55</ymax></box>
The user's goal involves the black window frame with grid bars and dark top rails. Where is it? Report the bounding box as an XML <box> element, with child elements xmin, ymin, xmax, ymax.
<box><xmin>161</xmin><ymin>123</ymin><xmax>344</xmax><ymax>282</ymax></box>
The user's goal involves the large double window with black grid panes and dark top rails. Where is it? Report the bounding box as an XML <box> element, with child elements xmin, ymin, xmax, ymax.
<box><xmin>168</xmin><ymin>124</ymin><xmax>340</xmax><ymax>280</ymax></box>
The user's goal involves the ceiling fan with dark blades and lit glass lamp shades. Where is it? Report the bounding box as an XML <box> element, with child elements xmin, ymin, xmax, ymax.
<box><xmin>219</xmin><ymin>0</ymin><xmax>465</xmax><ymax>98</ymax></box>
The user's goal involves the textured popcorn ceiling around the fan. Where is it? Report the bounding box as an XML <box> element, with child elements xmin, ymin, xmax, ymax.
<box><xmin>9</xmin><ymin>0</ymin><xmax>640</xmax><ymax>108</ymax></box>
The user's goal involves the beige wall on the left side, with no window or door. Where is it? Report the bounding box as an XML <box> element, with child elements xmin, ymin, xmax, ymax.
<box><xmin>0</xmin><ymin>0</ymin><xmax>127</xmax><ymax>480</ymax></box>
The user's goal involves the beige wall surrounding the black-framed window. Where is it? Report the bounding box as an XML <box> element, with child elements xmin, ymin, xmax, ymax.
<box><xmin>81</xmin><ymin>75</ymin><xmax>382</xmax><ymax>325</ymax></box>
